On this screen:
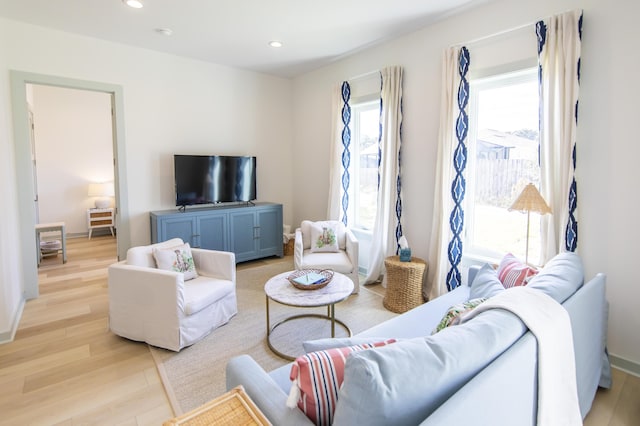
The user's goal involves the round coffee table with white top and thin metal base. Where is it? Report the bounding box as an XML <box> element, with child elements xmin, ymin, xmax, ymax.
<box><xmin>264</xmin><ymin>271</ymin><xmax>353</xmax><ymax>361</ymax></box>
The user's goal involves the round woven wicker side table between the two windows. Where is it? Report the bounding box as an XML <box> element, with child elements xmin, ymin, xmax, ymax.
<box><xmin>382</xmin><ymin>256</ymin><xmax>427</xmax><ymax>313</ymax></box>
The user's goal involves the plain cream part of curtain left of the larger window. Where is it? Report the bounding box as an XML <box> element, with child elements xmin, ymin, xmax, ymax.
<box><xmin>423</xmin><ymin>46</ymin><xmax>462</xmax><ymax>300</ymax></box>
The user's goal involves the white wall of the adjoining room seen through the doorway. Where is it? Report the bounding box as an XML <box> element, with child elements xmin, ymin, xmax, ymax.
<box><xmin>30</xmin><ymin>85</ymin><xmax>114</xmax><ymax>235</ymax></box>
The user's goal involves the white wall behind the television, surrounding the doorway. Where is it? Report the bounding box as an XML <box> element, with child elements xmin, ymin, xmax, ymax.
<box><xmin>0</xmin><ymin>19</ymin><xmax>293</xmax><ymax>338</ymax></box>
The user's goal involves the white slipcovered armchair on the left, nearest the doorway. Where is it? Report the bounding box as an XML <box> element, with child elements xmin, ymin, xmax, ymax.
<box><xmin>108</xmin><ymin>238</ymin><xmax>238</xmax><ymax>351</ymax></box>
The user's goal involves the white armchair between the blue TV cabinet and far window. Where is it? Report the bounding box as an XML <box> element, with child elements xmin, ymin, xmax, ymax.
<box><xmin>293</xmin><ymin>220</ymin><xmax>360</xmax><ymax>293</ymax></box>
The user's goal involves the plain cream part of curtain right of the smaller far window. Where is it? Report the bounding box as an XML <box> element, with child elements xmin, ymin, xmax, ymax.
<box><xmin>365</xmin><ymin>66</ymin><xmax>403</xmax><ymax>284</ymax></box>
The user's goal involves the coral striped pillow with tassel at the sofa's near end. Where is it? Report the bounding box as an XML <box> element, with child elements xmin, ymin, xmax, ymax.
<box><xmin>287</xmin><ymin>339</ymin><xmax>396</xmax><ymax>425</ymax></box>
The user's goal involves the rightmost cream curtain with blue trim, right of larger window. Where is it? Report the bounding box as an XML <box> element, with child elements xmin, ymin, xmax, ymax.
<box><xmin>536</xmin><ymin>10</ymin><xmax>582</xmax><ymax>262</ymax></box>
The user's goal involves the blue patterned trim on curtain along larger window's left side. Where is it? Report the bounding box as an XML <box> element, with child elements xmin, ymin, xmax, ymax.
<box><xmin>446</xmin><ymin>47</ymin><xmax>470</xmax><ymax>291</ymax></box>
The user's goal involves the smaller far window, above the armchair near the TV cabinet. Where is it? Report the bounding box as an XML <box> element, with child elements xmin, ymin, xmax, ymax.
<box><xmin>348</xmin><ymin>101</ymin><xmax>380</xmax><ymax>232</ymax></box>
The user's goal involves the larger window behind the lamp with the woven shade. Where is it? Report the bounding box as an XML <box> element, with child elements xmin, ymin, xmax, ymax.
<box><xmin>465</xmin><ymin>68</ymin><xmax>541</xmax><ymax>264</ymax></box>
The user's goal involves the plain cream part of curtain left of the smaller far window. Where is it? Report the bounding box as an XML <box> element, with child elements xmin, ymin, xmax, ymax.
<box><xmin>327</xmin><ymin>83</ymin><xmax>344</xmax><ymax>221</ymax></box>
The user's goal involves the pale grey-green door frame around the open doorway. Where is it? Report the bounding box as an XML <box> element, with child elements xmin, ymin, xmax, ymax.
<box><xmin>10</xmin><ymin>70</ymin><xmax>131</xmax><ymax>299</ymax></box>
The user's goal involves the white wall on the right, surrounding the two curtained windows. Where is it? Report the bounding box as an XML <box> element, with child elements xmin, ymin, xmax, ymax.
<box><xmin>293</xmin><ymin>0</ymin><xmax>640</xmax><ymax>365</ymax></box>
